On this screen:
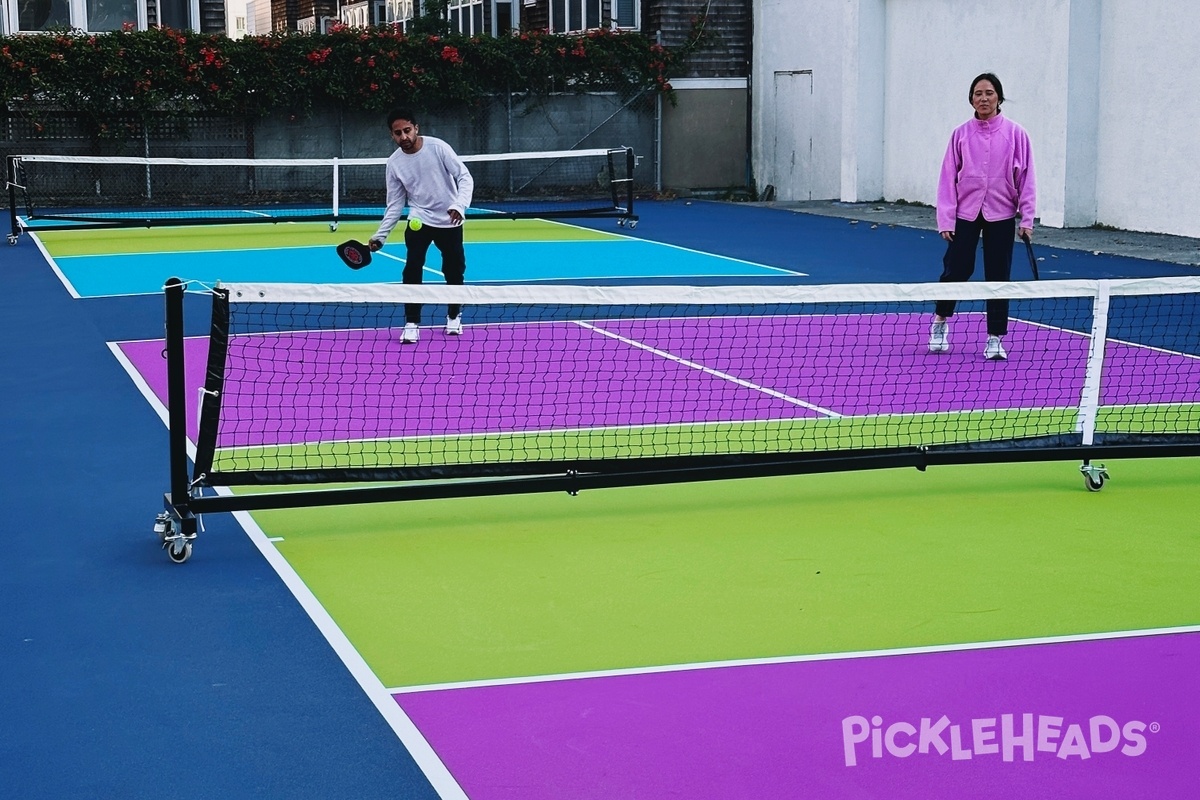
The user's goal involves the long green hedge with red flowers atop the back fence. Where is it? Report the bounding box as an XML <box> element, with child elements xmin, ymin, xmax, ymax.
<box><xmin>0</xmin><ymin>28</ymin><xmax>685</xmax><ymax>136</ymax></box>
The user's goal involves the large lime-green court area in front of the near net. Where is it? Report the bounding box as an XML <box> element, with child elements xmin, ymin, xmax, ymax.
<box><xmin>253</xmin><ymin>458</ymin><xmax>1200</xmax><ymax>687</ymax></box>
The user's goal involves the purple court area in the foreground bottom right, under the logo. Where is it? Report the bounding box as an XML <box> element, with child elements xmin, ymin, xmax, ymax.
<box><xmin>395</xmin><ymin>633</ymin><xmax>1200</xmax><ymax>800</ymax></box>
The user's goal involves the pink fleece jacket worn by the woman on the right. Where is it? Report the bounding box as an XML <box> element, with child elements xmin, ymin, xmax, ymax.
<box><xmin>937</xmin><ymin>114</ymin><xmax>1037</xmax><ymax>236</ymax></box>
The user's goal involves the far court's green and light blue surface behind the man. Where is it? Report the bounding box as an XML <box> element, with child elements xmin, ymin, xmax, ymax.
<box><xmin>32</xmin><ymin>219</ymin><xmax>794</xmax><ymax>297</ymax></box>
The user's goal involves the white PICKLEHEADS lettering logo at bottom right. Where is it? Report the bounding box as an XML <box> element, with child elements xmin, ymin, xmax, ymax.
<box><xmin>841</xmin><ymin>714</ymin><xmax>1159</xmax><ymax>766</ymax></box>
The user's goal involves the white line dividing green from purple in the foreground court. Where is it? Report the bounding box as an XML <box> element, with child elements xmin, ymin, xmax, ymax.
<box><xmin>388</xmin><ymin>625</ymin><xmax>1200</xmax><ymax>694</ymax></box>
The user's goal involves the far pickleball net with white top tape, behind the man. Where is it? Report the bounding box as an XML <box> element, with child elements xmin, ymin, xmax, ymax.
<box><xmin>8</xmin><ymin>148</ymin><xmax>635</xmax><ymax>225</ymax></box>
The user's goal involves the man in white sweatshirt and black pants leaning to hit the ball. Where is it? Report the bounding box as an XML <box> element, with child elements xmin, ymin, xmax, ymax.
<box><xmin>370</xmin><ymin>108</ymin><xmax>475</xmax><ymax>344</ymax></box>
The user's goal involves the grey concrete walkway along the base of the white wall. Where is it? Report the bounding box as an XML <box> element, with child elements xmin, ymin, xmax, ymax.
<box><xmin>748</xmin><ymin>200</ymin><xmax>1200</xmax><ymax>266</ymax></box>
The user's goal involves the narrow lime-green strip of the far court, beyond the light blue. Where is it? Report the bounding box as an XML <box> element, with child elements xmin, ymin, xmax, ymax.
<box><xmin>37</xmin><ymin>217</ymin><xmax>620</xmax><ymax>257</ymax></box>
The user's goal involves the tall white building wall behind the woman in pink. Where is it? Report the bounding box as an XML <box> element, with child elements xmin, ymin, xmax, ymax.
<box><xmin>751</xmin><ymin>0</ymin><xmax>1200</xmax><ymax>236</ymax></box>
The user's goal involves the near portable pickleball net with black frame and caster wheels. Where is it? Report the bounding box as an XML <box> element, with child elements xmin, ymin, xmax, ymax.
<box><xmin>151</xmin><ymin>277</ymin><xmax>1200</xmax><ymax>561</ymax></box>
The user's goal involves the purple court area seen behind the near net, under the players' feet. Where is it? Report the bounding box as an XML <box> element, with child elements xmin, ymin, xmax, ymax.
<box><xmin>121</xmin><ymin>314</ymin><xmax>1200</xmax><ymax>446</ymax></box>
